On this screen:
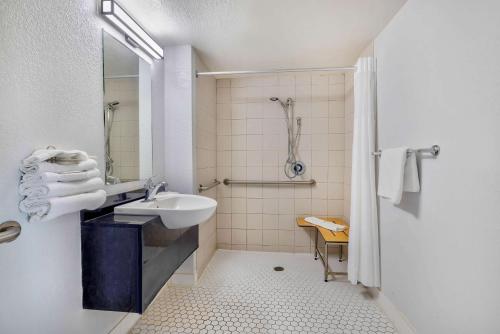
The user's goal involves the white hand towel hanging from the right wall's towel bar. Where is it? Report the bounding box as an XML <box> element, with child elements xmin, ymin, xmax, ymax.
<box><xmin>378</xmin><ymin>147</ymin><xmax>408</xmax><ymax>204</ymax></box>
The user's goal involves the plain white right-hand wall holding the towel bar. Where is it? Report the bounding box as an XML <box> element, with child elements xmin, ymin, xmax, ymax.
<box><xmin>375</xmin><ymin>0</ymin><xmax>500</xmax><ymax>334</ymax></box>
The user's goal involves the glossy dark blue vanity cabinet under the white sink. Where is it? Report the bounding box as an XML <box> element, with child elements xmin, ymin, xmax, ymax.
<box><xmin>81</xmin><ymin>197</ymin><xmax>198</xmax><ymax>313</ymax></box>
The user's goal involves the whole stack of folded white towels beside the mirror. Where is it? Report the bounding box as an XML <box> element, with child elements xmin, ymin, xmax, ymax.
<box><xmin>19</xmin><ymin>149</ymin><xmax>106</xmax><ymax>221</ymax></box>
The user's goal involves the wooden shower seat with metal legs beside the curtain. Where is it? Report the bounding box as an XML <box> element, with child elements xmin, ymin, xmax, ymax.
<box><xmin>297</xmin><ymin>217</ymin><xmax>349</xmax><ymax>282</ymax></box>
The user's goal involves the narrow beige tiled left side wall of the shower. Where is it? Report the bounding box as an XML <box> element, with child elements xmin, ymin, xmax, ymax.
<box><xmin>195</xmin><ymin>63</ymin><xmax>217</xmax><ymax>276</ymax></box>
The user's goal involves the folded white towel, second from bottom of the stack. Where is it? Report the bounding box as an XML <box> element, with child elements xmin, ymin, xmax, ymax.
<box><xmin>19</xmin><ymin>177</ymin><xmax>104</xmax><ymax>198</ymax></box>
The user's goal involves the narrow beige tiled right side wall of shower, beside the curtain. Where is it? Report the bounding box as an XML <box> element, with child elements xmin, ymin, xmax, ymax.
<box><xmin>344</xmin><ymin>72</ymin><xmax>354</xmax><ymax>221</ymax></box>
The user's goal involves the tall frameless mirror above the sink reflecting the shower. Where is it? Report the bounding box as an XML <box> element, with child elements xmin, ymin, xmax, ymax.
<box><xmin>103</xmin><ymin>31</ymin><xmax>152</xmax><ymax>184</ymax></box>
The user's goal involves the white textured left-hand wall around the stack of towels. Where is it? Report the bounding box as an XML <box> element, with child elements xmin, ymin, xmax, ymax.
<box><xmin>0</xmin><ymin>0</ymin><xmax>162</xmax><ymax>334</ymax></box>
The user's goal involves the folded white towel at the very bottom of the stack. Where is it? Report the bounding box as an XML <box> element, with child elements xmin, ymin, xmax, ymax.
<box><xmin>19</xmin><ymin>190</ymin><xmax>106</xmax><ymax>222</ymax></box>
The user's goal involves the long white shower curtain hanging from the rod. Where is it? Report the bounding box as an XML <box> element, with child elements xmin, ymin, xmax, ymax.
<box><xmin>348</xmin><ymin>57</ymin><xmax>380</xmax><ymax>287</ymax></box>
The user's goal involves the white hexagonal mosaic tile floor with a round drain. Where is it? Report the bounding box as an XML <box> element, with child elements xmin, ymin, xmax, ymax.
<box><xmin>131</xmin><ymin>250</ymin><xmax>396</xmax><ymax>334</ymax></box>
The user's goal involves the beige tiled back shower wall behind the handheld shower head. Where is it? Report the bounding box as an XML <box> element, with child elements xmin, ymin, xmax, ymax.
<box><xmin>217</xmin><ymin>72</ymin><xmax>346</xmax><ymax>252</ymax></box>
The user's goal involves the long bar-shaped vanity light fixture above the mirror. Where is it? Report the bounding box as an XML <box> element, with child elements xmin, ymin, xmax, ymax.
<box><xmin>101</xmin><ymin>0</ymin><xmax>163</xmax><ymax>59</ymax></box>
